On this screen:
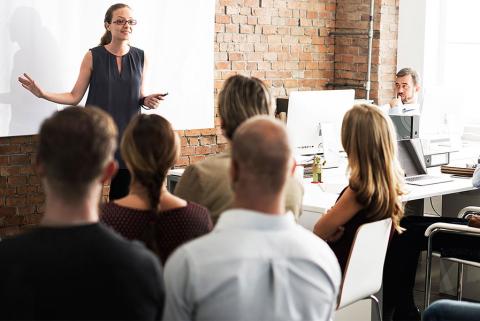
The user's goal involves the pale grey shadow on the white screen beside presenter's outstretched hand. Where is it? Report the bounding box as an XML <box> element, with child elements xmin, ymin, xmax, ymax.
<box><xmin>0</xmin><ymin>7</ymin><xmax>63</xmax><ymax>136</ymax></box>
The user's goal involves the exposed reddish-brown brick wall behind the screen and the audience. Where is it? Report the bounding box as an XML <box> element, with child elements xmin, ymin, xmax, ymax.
<box><xmin>0</xmin><ymin>0</ymin><xmax>399</xmax><ymax>237</ymax></box>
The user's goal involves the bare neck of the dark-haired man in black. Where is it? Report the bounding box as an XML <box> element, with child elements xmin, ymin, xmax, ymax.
<box><xmin>40</xmin><ymin>191</ymin><xmax>100</xmax><ymax>227</ymax></box>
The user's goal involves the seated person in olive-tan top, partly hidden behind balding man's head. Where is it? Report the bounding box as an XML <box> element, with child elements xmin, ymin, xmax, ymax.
<box><xmin>175</xmin><ymin>75</ymin><xmax>303</xmax><ymax>222</ymax></box>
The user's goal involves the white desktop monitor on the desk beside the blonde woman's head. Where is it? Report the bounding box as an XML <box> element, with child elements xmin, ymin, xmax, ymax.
<box><xmin>287</xmin><ymin>89</ymin><xmax>355</xmax><ymax>155</ymax></box>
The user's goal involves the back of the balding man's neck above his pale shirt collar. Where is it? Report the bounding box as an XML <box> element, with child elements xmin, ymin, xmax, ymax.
<box><xmin>233</xmin><ymin>192</ymin><xmax>285</xmax><ymax>215</ymax></box>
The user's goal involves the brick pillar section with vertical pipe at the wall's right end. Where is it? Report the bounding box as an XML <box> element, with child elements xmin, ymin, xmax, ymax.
<box><xmin>334</xmin><ymin>0</ymin><xmax>399</xmax><ymax>104</ymax></box>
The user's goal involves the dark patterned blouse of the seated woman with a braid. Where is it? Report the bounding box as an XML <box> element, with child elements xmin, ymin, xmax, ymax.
<box><xmin>100</xmin><ymin>202</ymin><xmax>213</xmax><ymax>264</ymax></box>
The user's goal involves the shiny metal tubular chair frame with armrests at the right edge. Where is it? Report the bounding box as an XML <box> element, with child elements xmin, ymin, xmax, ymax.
<box><xmin>425</xmin><ymin>206</ymin><xmax>480</xmax><ymax>309</ymax></box>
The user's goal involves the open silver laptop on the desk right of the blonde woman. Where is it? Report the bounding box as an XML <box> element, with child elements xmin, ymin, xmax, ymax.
<box><xmin>397</xmin><ymin>138</ymin><xmax>453</xmax><ymax>186</ymax></box>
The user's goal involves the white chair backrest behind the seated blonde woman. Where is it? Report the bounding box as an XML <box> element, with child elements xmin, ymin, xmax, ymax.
<box><xmin>337</xmin><ymin>218</ymin><xmax>392</xmax><ymax>309</ymax></box>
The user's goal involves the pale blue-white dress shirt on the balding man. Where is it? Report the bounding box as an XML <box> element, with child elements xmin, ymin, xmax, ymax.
<box><xmin>163</xmin><ymin>209</ymin><xmax>341</xmax><ymax>321</ymax></box>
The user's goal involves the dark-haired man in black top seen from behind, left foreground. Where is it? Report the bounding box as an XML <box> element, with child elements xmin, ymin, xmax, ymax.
<box><xmin>0</xmin><ymin>107</ymin><xmax>164</xmax><ymax>320</ymax></box>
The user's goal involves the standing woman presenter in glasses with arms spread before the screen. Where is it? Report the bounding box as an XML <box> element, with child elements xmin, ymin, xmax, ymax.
<box><xmin>18</xmin><ymin>3</ymin><xmax>165</xmax><ymax>200</ymax></box>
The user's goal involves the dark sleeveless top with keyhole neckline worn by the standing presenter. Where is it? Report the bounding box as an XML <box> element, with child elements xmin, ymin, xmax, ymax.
<box><xmin>86</xmin><ymin>46</ymin><xmax>144</xmax><ymax>168</ymax></box>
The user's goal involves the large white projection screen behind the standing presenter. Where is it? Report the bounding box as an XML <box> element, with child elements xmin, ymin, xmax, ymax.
<box><xmin>0</xmin><ymin>0</ymin><xmax>215</xmax><ymax>136</ymax></box>
